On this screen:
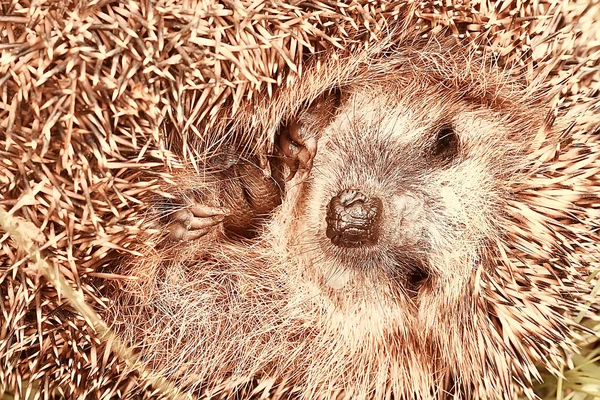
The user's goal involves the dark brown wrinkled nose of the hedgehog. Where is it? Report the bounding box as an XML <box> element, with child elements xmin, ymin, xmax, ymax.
<box><xmin>325</xmin><ymin>189</ymin><xmax>381</xmax><ymax>247</ymax></box>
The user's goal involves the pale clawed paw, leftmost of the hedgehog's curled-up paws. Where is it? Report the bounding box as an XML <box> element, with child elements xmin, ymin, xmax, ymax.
<box><xmin>169</xmin><ymin>204</ymin><xmax>231</xmax><ymax>241</ymax></box>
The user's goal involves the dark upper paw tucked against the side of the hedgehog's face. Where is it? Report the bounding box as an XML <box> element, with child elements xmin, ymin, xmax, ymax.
<box><xmin>279</xmin><ymin>88</ymin><xmax>343</xmax><ymax>180</ymax></box>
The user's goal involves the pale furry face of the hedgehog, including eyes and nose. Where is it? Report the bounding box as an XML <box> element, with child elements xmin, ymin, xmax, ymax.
<box><xmin>276</xmin><ymin>87</ymin><xmax>510</xmax><ymax>322</ymax></box>
